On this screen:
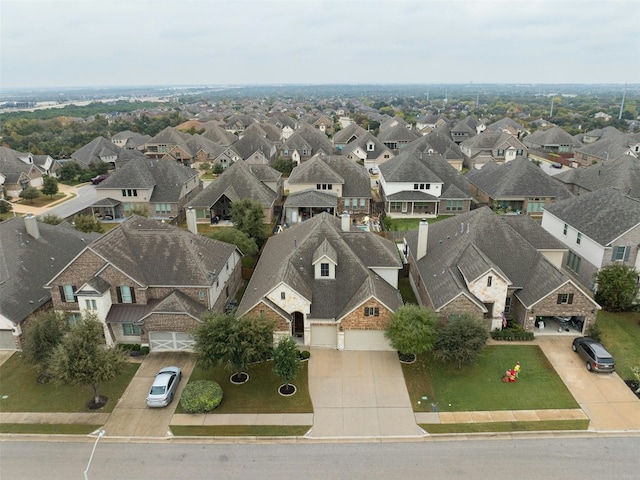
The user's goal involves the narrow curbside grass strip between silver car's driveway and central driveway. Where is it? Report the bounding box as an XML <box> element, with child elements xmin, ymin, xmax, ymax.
<box><xmin>171</xmin><ymin>425</ymin><xmax>311</xmax><ymax>437</ymax></box>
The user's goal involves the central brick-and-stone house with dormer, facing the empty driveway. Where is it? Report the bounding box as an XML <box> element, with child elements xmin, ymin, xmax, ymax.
<box><xmin>237</xmin><ymin>213</ymin><xmax>403</xmax><ymax>350</ymax></box>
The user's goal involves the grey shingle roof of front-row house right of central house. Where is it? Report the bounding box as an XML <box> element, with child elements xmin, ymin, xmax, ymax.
<box><xmin>406</xmin><ymin>207</ymin><xmax>568</xmax><ymax>311</ymax></box>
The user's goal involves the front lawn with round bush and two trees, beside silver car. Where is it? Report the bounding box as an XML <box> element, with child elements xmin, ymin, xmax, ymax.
<box><xmin>176</xmin><ymin>361</ymin><xmax>313</xmax><ymax>413</ymax></box>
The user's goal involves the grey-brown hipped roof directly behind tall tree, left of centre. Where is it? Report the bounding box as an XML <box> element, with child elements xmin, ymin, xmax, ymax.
<box><xmin>187</xmin><ymin>160</ymin><xmax>277</xmax><ymax>208</ymax></box>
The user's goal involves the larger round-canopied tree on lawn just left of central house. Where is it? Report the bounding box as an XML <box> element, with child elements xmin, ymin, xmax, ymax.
<box><xmin>194</xmin><ymin>313</ymin><xmax>273</xmax><ymax>383</ymax></box>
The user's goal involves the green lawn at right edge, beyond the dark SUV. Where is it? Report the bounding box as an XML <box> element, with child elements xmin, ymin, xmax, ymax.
<box><xmin>597</xmin><ymin>311</ymin><xmax>640</xmax><ymax>380</ymax></box>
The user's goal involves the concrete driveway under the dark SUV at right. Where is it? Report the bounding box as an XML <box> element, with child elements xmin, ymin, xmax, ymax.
<box><xmin>536</xmin><ymin>336</ymin><xmax>640</xmax><ymax>431</ymax></box>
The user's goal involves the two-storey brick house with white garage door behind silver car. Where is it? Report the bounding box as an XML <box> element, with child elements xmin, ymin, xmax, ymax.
<box><xmin>46</xmin><ymin>215</ymin><xmax>242</xmax><ymax>351</ymax></box>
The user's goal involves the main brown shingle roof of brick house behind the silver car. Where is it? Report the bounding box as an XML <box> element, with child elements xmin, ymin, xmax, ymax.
<box><xmin>55</xmin><ymin>215</ymin><xmax>236</xmax><ymax>287</ymax></box>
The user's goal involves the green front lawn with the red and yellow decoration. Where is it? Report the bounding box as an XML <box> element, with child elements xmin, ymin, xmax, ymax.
<box><xmin>402</xmin><ymin>345</ymin><xmax>578</xmax><ymax>412</ymax></box>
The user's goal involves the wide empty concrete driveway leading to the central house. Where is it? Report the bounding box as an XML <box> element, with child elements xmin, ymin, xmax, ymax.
<box><xmin>309</xmin><ymin>349</ymin><xmax>424</xmax><ymax>438</ymax></box>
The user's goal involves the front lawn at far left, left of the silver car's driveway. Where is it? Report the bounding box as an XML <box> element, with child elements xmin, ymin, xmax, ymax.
<box><xmin>0</xmin><ymin>353</ymin><xmax>140</xmax><ymax>413</ymax></box>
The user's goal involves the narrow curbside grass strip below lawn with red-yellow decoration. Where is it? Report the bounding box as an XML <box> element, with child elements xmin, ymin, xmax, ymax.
<box><xmin>419</xmin><ymin>419</ymin><xmax>589</xmax><ymax>434</ymax></box>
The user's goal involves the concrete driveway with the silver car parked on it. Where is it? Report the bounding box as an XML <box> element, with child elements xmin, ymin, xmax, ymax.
<box><xmin>103</xmin><ymin>352</ymin><xmax>195</xmax><ymax>438</ymax></box>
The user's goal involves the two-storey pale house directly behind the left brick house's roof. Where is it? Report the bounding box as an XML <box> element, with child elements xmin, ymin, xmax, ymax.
<box><xmin>91</xmin><ymin>157</ymin><xmax>202</xmax><ymax>220</ymax></box>
